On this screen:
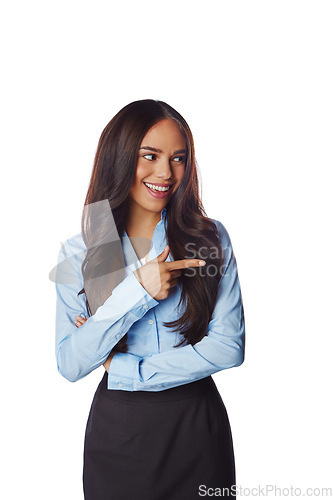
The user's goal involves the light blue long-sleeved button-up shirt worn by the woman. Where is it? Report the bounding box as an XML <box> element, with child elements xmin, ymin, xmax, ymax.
<box><xmin>55</xmin><ymin>209</ymin><xmax>245</xmax><ymax>391</ymax></box>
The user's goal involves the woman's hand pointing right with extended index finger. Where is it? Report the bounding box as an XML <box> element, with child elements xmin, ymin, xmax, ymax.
<box><xmin>133</xmin><ymin>245</ymin><xmax>206</xmax><ymax>300</ymax></box>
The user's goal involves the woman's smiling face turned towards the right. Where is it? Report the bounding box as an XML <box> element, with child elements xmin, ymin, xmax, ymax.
<box><xmin>130</xmin><ymin>119</ymin><xmax>186</xmax><ymax>220</ymax></box>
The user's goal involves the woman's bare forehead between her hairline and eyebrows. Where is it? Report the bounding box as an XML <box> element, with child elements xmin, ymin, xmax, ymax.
<box><xmin>141</xmin><ymin>119</ymin><xmax>186</xmax><ymax>149</ymax></box>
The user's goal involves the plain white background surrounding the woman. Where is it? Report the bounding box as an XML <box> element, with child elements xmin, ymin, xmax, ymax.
<box><xmin>0</xmin><ymin>0</ymin><xmax>333</xmax><ymax>500</ymax></box>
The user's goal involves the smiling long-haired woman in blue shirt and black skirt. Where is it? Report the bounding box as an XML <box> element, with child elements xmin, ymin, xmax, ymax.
<box><xmin>56</xmin><ymin>99</ymin><xmax>245</xmax><ymax>500</ymax></box>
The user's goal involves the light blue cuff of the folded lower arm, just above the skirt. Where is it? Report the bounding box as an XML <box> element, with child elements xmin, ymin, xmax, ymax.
<box><xmin>108</xmin><ymin>351</ymin><xmax>143</xmax><ymax>391</ymax></box>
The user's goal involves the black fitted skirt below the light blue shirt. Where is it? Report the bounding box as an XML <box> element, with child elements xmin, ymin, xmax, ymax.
<box><xmin>83</xmin><ymin>371</ymin><xmax>236</xmax><ymax>500</ymax></box>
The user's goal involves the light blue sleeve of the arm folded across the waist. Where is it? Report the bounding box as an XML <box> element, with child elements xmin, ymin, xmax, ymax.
<box><xmin>108</xmin><ymin>221</ymin><xmax>245</xmax><ymax>391</ymax></box>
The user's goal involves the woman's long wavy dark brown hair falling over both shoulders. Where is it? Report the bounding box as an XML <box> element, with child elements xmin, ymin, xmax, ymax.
<box><xmin>79</xmin><ymin>99</ymin><xmax>223</xmax><ymax>352</ymax></box>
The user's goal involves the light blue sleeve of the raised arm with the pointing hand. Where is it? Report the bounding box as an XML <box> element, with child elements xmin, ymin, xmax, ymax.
<box><xmin>55</xmin><ymin>240</ymin><xmax>159</xmax><ymax>382</ymax></box>
